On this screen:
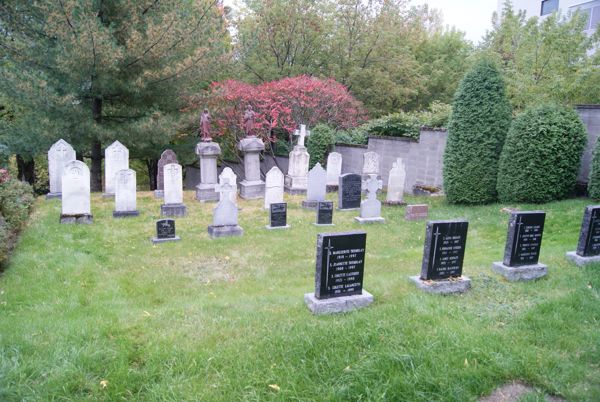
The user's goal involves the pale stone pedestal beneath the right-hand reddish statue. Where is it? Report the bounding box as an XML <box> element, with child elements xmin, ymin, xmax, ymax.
<box><xmin>238</xmin><ymin>136</ymin><xmax>265</xmax><ymax>200</ymax></box>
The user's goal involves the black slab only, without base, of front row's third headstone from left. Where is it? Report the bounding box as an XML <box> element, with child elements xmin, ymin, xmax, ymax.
<box><xmin>503</xmin><ymin>211</ymin><xmax>546</xmax><ymax>267</ymax></box>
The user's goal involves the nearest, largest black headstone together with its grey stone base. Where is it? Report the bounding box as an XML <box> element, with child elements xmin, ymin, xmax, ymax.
<box><xmin>304</xmin><ymin>231</ymin><xmax>373</xmax><ymax>314</ymax></box>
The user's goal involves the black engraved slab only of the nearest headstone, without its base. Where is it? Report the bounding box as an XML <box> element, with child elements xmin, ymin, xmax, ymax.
<box><xmin>315</xmin><ymin>231</ymin><xmax>367</xmax><ymax>299</ymax></box>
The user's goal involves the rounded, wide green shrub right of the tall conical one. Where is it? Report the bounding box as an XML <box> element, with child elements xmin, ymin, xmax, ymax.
<box><xmin>498</xmin><ymin>105</ymin><xmax>587</xmax><ymax>202</ymax></box>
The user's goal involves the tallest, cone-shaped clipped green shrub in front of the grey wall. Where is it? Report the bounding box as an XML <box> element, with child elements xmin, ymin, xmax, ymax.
<box><xmin>444</xmin><ymin>60</ymin><xmax>511</xmax><ymax>204</ymax></box>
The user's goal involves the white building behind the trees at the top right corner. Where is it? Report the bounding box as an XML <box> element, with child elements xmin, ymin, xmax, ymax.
<box><xmin>498</xmin><ymin>0</ymin><xmax>600</xmax><ymax>35</ymax></box>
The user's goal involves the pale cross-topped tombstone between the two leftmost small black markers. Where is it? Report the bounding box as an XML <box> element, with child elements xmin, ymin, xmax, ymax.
<box><xmin>208</xmin><ymin>177</ymin><xmax>244</xmax><ymax>239</ymax></box>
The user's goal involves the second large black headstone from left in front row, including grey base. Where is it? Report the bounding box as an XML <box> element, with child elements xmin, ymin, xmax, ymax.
<box><xmin>410</xmin><ymin>220</ymin><xmax>471</xmax><ymax>294</ymax></box>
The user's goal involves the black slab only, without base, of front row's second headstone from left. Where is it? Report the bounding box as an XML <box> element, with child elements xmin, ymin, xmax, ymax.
<box><xmin>421</xmin><ymin>220</ymin><xmax>469</xmax><ymax>280</ymax></box>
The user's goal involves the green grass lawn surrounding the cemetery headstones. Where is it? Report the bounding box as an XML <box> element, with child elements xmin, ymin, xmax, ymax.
<box><xmin>0</xmin><ymin>192</ymin><xmax>600</xmax><ymax>401</ymax></box>
